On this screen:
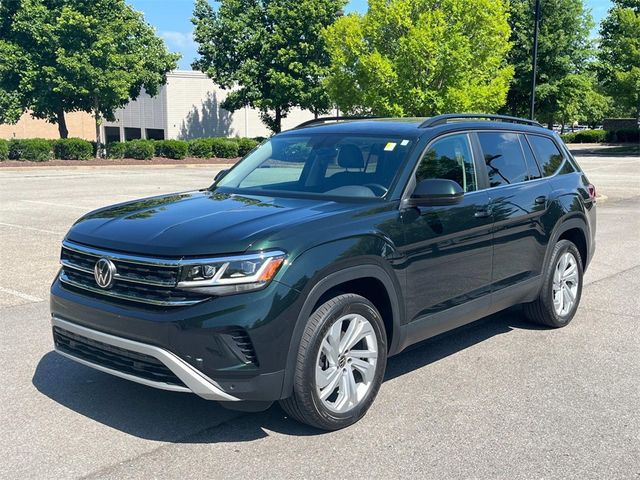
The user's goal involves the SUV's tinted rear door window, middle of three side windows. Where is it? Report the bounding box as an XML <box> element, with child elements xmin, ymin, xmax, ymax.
<box><xmin>478</xmin><ymin>132</ymin><xmax>529</xmax><ymax>187</ymax></box>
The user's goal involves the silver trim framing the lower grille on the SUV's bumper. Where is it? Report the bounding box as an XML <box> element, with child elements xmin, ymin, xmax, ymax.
<box><xmin>51</xmin><ymin>317</ymin><xmax>240</xmax><ymax>401</ymax></box>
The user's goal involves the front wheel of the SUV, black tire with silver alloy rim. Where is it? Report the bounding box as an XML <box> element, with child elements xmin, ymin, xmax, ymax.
<box><xmin>280</xmin><ymin>294</ymin><xmax>387</xmax><ymax>430</ymax></box>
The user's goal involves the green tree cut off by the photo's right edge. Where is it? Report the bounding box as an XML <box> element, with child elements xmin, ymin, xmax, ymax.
<box><xmin>598</xmin><ymin>0</ymin><xmax>640</xmax><ymax>118</ymax></box>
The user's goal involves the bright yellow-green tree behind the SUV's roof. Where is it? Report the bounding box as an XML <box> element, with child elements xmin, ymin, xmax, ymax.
<box><xmin>325</xmin><ymin>0</ymin><xmax>513</xmax><ymax>116</ymax></box>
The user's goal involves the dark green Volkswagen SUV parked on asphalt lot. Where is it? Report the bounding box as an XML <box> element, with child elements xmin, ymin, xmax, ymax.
<box><xmin>51</xmin><ymin>115</ymin><xmax>595</xmax><ymax>430</ymax></box>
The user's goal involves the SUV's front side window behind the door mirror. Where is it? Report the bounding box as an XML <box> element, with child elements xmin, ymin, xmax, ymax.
<box><xmin>416</xmin><ymin>134</ymin><xmax>478</xmax><ymax>192</ymax></box>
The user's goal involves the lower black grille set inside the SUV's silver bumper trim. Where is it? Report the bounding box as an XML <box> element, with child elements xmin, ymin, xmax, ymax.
<box><xmin>53</xmin><ymin>327</ymin><xmax>185</xmax><ymax>386</ymax></box>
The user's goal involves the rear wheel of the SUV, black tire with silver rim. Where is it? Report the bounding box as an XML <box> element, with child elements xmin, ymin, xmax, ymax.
<box><xmin>524</xmin><ymin>240</ymin><xmax>583</xmax><ymax>328</ymax></box>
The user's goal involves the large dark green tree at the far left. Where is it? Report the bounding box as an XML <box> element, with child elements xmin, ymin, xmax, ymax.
<box><xmin>0</xmin><ymin>0</ymin><xmax>179</xmax><ymax>138</ymax></box>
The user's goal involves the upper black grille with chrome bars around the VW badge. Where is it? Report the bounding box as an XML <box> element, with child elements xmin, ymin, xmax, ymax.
<box><xmin>60</xmin><ymin>242</ymin><xmax>208</xmax><ymax>306</ymax></box>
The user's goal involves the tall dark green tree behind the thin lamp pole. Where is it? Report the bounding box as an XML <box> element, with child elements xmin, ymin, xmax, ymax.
<box><xmin>505</xmin><ymin>0</ymin><xmax>593</xmax><ymax>128</ymax></box>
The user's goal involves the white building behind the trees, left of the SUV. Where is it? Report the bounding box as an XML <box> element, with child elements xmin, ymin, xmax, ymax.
<box><xmin>102</xmin><ymin>70</ymin><xmax>313</xmax><ymax>143</ymax></box>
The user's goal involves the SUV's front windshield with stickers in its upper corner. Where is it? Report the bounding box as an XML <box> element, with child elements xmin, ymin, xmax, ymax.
<box><xmin>215</xmin><ymin>133</ymin><xmax>413</xmax><ymax>198</ymax></box>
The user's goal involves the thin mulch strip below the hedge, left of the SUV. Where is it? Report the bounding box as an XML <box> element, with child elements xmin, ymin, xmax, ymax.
<box><xmin>0</xmin><ymin>157</ymin><xmax>238</xmax><ymax>168</ymax></box>
